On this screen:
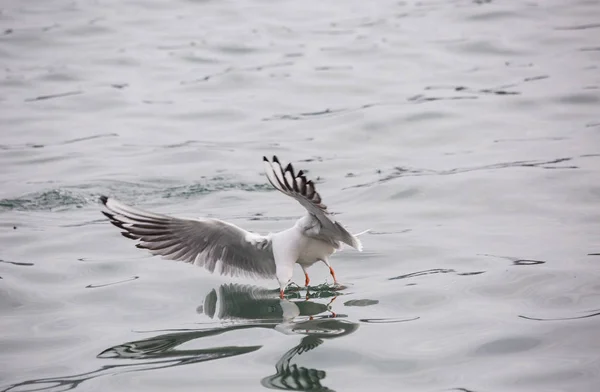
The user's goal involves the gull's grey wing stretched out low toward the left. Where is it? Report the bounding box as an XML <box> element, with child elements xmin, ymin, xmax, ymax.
<box><xmin>100</xmin><ymin>196</ymin><xmax>276</xmax><ymax>278</ymax></box>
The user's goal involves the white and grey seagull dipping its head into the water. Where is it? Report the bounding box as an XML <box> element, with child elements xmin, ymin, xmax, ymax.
<box><xmin>100</xmin><ymin>156</ymin><xmax>368</xmax><ymax>298</ymax></box>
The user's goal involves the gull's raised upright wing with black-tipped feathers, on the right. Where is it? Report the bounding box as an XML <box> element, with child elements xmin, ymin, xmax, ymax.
<box><xmin>263</xmin><ymin>156</ymin><xmax>362</xmax><ymax>251</ymax></box>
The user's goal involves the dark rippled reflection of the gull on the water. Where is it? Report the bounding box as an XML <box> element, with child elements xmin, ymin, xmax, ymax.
<box><xmin>2</xmin><ymin>284</ymin><xmax>358</xmax><ymax>392</ymax></box>
